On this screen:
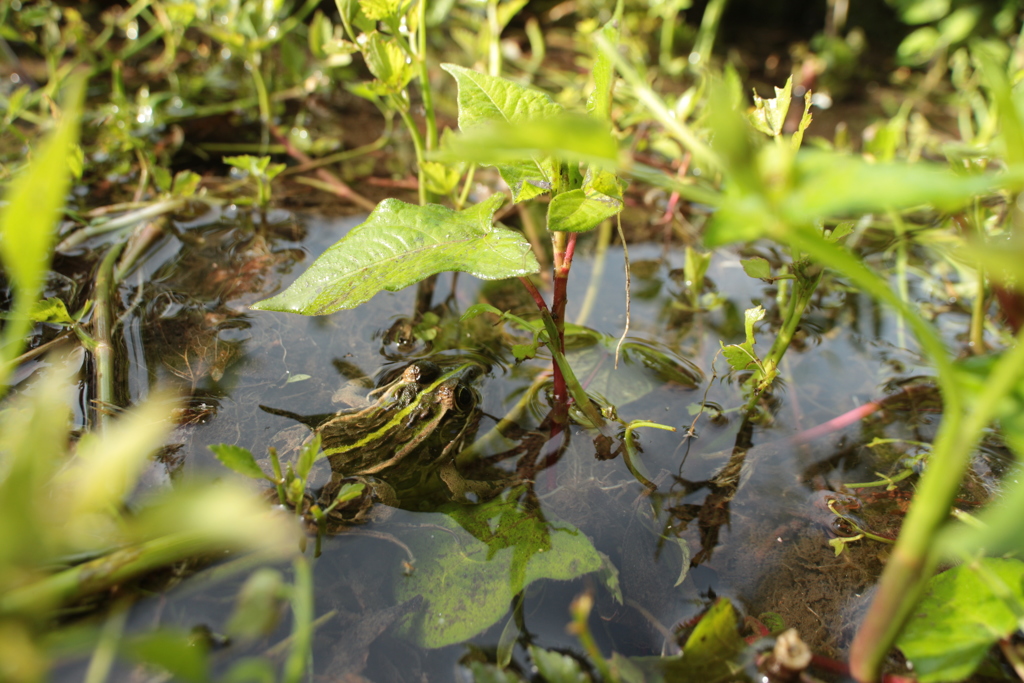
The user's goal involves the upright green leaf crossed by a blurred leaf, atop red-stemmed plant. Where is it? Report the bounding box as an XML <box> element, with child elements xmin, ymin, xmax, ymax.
<box><xmin>441</xmin><ymin>63</ymin><xmax>564</xmax><ymax>202</ymax></box>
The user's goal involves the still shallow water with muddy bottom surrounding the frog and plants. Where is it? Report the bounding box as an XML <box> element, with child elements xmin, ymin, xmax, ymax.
<box><xmin>46</xmin><ymin>205</ymin><xmax>991</xmax><ymax>681</ymax></box>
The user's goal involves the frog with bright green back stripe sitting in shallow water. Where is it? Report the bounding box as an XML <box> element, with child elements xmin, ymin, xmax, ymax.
<box><xmin>313</xmin><ymin>358</ymin><xmax>507</xmax><ymax>522</ymax></box>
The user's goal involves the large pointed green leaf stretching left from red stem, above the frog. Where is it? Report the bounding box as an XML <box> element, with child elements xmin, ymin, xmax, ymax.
<box><xmin>252</xmin><ymin>195</ymin><xmax>541</xmax><ymax>315</ymax></box>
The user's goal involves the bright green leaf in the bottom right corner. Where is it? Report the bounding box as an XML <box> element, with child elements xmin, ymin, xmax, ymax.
<box><xmin>896</xmin><ymin>558</ymin><xmax>1024</xmax><ymax>683</ymax></box>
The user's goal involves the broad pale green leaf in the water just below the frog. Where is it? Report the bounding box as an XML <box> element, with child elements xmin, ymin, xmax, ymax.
<box><xmin>396</xmin><ymin>488</ymin><xmax>601</xmax><ymax>647</ymax></box>
